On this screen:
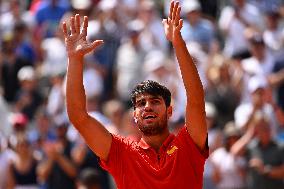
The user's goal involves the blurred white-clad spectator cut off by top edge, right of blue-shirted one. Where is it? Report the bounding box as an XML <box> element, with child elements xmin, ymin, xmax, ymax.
<box><xmin>218</xmin><ymin>0</ymin><xmax>263</xmax><ymax>58</ymax></box>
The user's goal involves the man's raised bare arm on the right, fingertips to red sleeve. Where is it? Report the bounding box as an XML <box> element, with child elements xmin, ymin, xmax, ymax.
<box><xmin>163</xmin><ymin>1</ymin><xmax>207</xmax><ymax>150</ymax></box>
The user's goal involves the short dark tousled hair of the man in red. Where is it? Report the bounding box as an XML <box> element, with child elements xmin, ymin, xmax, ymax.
<box><xmin>131</xmin><ymin>80</ymin><xmax>171</xmax><ymax>109</ymax></box>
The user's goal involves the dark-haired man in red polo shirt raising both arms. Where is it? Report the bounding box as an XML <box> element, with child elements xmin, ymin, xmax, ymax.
<box><xmin>63</xmin><ymin>2</ymin><xmax>208</xmax><ymax>189</ymax></box>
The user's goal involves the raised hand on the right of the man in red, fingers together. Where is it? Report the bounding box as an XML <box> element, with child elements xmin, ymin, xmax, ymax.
<box><xmin>163</xmin><ymin>1</ymin><xmax>183</xmax><ymax>43</ymax></box>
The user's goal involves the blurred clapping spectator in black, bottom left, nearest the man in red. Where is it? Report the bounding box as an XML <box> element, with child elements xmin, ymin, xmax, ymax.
<box><xmin>39</xmin><ymin>121</ymin><xmax>76</xmax><ymax>189</ymax></box>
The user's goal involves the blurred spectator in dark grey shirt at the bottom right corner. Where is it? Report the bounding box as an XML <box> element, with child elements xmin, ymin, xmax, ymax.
<box><xmin>233</xmin><ymin>113</ymin><xmax>284</xmax><ymax>189</ymax></box>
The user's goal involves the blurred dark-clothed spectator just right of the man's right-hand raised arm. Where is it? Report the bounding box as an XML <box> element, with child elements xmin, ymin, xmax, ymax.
<box><xmin>205</xmin><ymin>56</ymin><xmax>242</xmax><ymax>128</ymax></box>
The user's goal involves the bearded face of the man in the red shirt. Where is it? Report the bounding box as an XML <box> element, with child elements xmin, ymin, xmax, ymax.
<box><xmin>134</xmin><ymin>94</ymin><xmax>172</xmax><ymax>136</ymax></box>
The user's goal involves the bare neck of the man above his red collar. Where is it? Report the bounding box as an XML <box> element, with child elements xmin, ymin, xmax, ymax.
<box><xmin>142</xmin><ymin>129</ymin><xmax>170</xmax><ymax>152</ymax></box>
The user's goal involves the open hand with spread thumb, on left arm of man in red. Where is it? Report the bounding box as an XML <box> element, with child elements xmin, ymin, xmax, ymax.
<box><xmin>62</xmin><ymin>14</ymin><xmax>103</xmax><ymax>57</ymax></box>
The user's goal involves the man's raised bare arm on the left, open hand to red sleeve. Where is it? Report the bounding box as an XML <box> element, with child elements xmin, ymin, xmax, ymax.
<box><xmin>63</xmin><ymin>14</ymin><xmax>112</xmax><ymax>160</ymax></box>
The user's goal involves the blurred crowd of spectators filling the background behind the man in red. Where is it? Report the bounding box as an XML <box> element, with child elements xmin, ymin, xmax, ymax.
<box><xmin>0</xmin><ymin>0</ymin><xmax>284</xmax><ymax>189</ymax></box>
